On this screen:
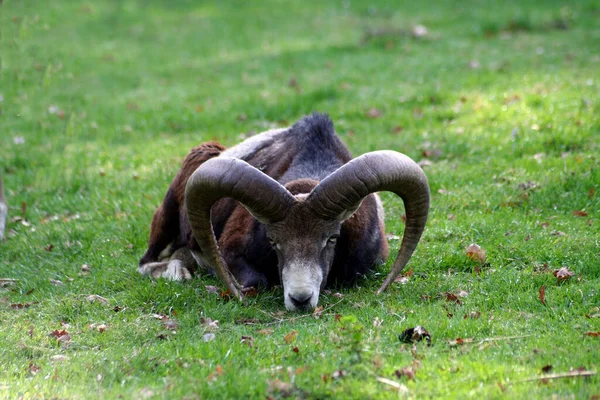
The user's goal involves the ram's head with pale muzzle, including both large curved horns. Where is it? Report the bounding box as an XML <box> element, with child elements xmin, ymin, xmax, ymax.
<box><xmin>185</xmin><ymin>151</ymin><xmax>429</xmax><ymax>310</ymax></box>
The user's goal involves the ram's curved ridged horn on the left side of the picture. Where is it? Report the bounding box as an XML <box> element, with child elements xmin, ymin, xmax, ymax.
<box><xmin>185</xmin><ymin>157</ymin><xmax>296</xmax><ymax>298</ymax></box>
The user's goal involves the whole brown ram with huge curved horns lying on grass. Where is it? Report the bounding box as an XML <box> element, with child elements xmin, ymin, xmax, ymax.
<box><xmin>138</xmin><ymin>114</ymin><xmax>429</xmax><ymax>310</ymax></box>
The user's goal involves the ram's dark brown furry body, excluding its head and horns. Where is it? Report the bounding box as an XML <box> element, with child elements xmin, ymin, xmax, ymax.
<box><xmin>140</xmin><ymin>114</ymin><xmax>389</xmax><ymax>287</ymax></box>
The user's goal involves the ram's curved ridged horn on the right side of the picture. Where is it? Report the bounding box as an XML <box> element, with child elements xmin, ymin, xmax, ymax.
<box><xmin>306</xmin><ymin>150</ymin><xmax>429</xmax><ymax>294</ymax></box>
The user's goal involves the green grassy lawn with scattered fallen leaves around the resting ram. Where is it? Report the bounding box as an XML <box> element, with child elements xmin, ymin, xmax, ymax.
<box><xmin>0</xmin><ymin>0</ymin><xmax>600</xmax><ymax>399</ymax></box>
